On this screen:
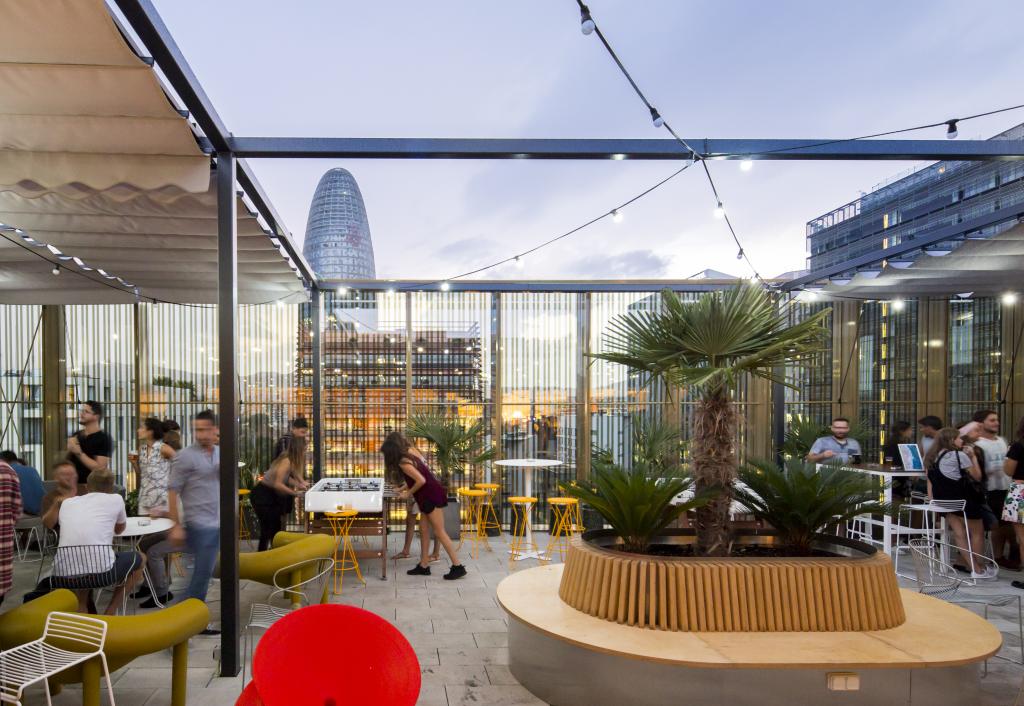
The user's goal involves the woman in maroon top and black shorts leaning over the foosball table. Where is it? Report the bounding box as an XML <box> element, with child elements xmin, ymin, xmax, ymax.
<box><xmin>381</xmin><ymin>431</ymin><xmax>466</xmax><ymax>581</ymax></box>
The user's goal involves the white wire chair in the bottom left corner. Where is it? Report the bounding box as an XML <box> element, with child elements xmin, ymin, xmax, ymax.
<box><xmin>0</xmin><ymin>612</ymin><xmax>114</xmax><ymax>706</ymax></box>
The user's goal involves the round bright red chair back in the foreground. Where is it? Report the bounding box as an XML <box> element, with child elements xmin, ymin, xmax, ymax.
<box><xmin>253</xmin><ymin>605</ymin><xmax>420</xmax><ymax>706</ymax></box>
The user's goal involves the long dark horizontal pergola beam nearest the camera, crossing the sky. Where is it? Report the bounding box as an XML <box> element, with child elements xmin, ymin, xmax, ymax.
<box><xmin>220</xmin><ymin>136</ymin><xmax>1024</xmax><ymax>161</ymax></box>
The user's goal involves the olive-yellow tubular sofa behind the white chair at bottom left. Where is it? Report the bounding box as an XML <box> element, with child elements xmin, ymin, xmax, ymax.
<box><xmin>0</xmin><ymin>588</ymin><xmax>210</xmax><ymax>706</ymax></box>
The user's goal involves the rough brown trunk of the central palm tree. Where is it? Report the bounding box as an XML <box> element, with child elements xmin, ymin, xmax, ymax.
<box><xmin>690</xmin><ymin>389</ymin><xmax>736</xmax><ymax>556</ymax></box>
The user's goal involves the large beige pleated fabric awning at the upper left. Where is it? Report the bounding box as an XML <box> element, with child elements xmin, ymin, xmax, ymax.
<box><xmin>0</xmin><ymin>0</ymin><xmax>302</xmax><ymax>303</ymax></box>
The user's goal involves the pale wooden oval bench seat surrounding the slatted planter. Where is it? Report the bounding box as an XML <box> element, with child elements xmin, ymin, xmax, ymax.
<box><xmin>498</xmin><ymin>565</ymin><xmax>1002</xmax><ymax>669</ymax></box>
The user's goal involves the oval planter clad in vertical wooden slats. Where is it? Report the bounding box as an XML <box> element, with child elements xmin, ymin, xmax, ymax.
<box><xmin>558</xmin><ymin>530</ymin><xmax>906</xmax><ymax>632</ymax></box>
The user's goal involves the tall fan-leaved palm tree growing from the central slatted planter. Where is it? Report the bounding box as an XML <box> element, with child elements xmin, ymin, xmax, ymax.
<box><xmin>592</xmin><ymin>283</ymin><xmax>828</xmax><ymax>556</ymax></box>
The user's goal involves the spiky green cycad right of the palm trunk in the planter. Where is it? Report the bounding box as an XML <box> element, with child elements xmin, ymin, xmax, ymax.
<box><xmin>734</xmin><ymin>459</ymin><xmax>890</xmax><ymax>556</ymax></box>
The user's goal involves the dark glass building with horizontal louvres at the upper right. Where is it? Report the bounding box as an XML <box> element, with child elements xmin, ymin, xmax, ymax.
<box><xmin>807</xmin><ymin>124</ymin><xmax>1024</xmax><ymax>272</ymax></box>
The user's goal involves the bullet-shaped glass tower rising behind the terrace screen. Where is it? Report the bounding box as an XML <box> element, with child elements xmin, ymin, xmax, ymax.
<box><xmin>302</xmin><ymin>168</ymin><xmax>377</xmax><ymax>280</ymax></box>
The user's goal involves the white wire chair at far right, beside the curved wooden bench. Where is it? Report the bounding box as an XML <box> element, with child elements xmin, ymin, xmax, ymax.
<box><xmin>908</xmin><ymin>539</ymin><xmax>1024</xmax><ymax>672</ymax></box>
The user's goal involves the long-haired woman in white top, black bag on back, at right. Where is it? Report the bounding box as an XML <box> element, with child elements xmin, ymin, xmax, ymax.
<box><xmin>925</xmin><ymin>426</ymin><xmax>985</xmax><ymax>575</ymax></box>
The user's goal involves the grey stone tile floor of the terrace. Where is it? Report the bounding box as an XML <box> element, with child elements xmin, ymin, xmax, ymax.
<box><xmin>5</xmin><ymin>535</ymin><xmax>1024</xmax><ymax>706</ymax></box>
